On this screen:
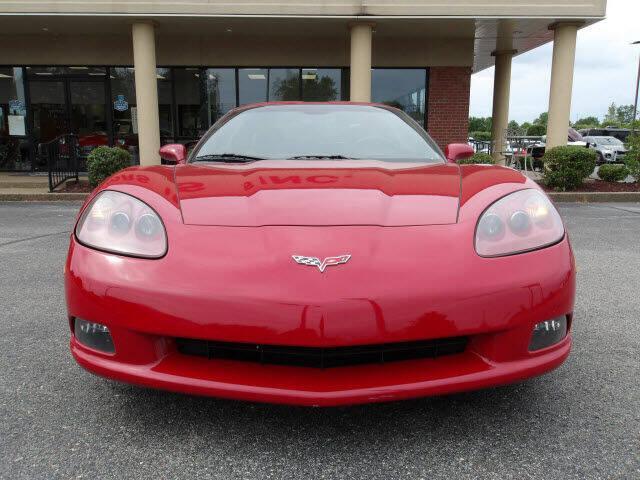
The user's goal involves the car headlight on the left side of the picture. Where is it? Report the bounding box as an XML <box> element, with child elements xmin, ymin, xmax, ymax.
<box><xmin>76</xmin><ymin>190</ymin><xmax>167</xmax><ymax>258</ymax></box>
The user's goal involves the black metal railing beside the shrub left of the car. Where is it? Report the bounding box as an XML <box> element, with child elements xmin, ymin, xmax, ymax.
<box><xmin>38</xmin><ymin>134</ymin><xmax>78</xmax><ymax>192</ymax></box>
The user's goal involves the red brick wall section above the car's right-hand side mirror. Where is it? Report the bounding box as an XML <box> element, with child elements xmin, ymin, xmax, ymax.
<box><xmin>427</xmin><ymin>67</ymin><xmax>471</xmax><ymax>150</ymax></box>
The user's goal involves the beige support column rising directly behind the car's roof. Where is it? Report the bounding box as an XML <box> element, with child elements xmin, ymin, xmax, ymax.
<box><xmin>350</xmin><ymin>23</ymin><xmax>374</xmax><ymax>102</ymax></box>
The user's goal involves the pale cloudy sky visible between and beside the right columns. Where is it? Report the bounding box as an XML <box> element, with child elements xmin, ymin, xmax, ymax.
<box><xmin>470</xmin><ymin>0</ymin><xmax>640</xmax><ymax>123</ymax></box>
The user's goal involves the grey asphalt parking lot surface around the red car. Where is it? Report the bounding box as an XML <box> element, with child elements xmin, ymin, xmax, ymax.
<box><xmin>0</xmin><ymin>203</ymin><xmax>640</xmax><ymax>479</ymax></box>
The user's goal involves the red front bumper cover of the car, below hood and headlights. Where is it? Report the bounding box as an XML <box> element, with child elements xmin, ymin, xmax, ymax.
<box><xmin>65</xmin><ymin>226</ymin><xmax>575</xmax><ymax>406</ymax></box>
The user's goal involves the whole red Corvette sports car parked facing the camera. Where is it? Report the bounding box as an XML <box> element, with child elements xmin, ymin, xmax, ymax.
<box><xmin>65</xmin><ymin>102</ymin><xmax>575</xmax><ymax>406</ymax></box>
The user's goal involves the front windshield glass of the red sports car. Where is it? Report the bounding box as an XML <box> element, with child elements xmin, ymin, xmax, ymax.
<box><xmin>191</xmin><ymin>104</ymin><xmax>444</xmax><ymax>163</ymax></box>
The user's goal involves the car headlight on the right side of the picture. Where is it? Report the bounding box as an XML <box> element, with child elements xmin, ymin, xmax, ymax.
<box><xmin>476</xmin><ymin>190</ymin><xmax>564</xmax><ymax>257</ymax></box>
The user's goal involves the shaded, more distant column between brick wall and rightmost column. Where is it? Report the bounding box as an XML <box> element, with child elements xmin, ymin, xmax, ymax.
<box><xmin>491</xmin><ymin>50</ymin><xmax>517</xmax><ymax>165</ymax></box>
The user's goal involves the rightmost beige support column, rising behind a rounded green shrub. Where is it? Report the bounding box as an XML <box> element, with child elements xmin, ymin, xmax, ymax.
<box><xmin>547</xmin><ymin>22</ymin><xmax>581</xmax><ymax>149</ymax></box>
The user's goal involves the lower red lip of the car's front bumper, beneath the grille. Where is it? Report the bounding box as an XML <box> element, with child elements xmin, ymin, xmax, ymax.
<box><xmin>71</xmin><ymin>336</ymin><xmax>571</xmax><ymax>406</ymax></box>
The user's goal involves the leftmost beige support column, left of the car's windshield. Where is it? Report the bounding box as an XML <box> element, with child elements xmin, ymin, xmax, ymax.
<box><xmin>132</xmin><ymin>22</ymin><xmax>160</xmax><ymax>165</ymax></box>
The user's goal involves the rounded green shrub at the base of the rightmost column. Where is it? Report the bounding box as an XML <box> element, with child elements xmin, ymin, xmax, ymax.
<box><xmin>542</xmin><ymin>146</ymin><xmax>597</xmax><ymax>191</ymax></box>
